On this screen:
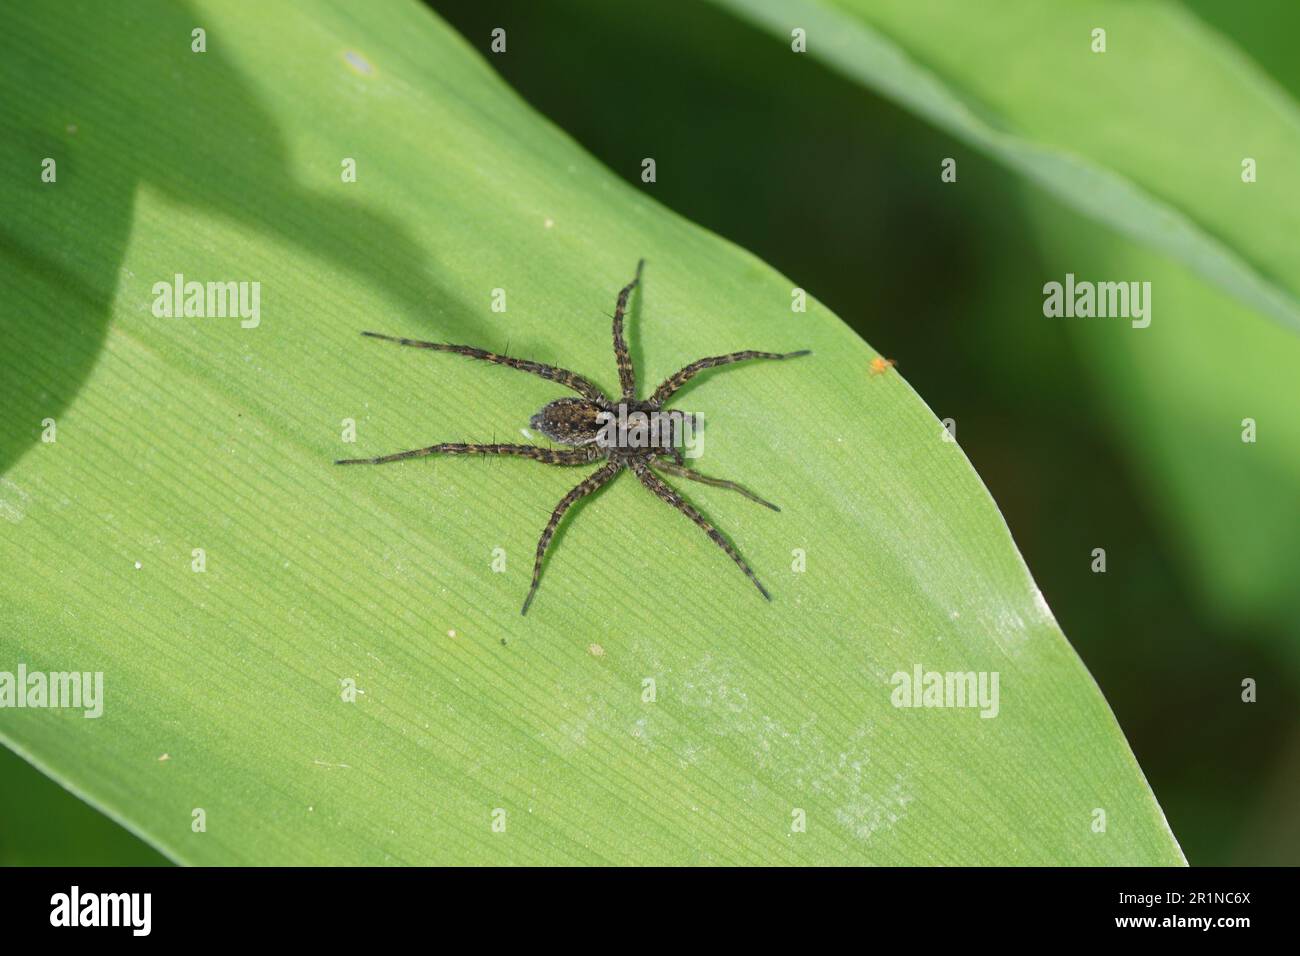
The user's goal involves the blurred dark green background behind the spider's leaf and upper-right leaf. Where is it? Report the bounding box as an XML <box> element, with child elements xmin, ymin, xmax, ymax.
<box><xmin>0</xmin><ymin>0</ymin><xmax>1300</xmax><ymax>865</ymax></box>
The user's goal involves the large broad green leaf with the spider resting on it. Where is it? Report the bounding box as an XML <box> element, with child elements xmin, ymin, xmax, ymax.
<box><xmin>0</xmin><ymin>3</ymin><xmax>1182</xmax><ymax>864</ymax></box>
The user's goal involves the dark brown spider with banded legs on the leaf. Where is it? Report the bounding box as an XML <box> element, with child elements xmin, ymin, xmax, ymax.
<box><xmin>335</xmin><ymin>259</ymin><xmax>810</xmax><ymax>614</ymax></box>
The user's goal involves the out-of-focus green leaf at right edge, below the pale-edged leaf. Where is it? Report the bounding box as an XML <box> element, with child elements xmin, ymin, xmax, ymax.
<box><xmin>1026</xmin><ymin>191</ymin><xmax>1300</xmax><ymax>665</ymax></box>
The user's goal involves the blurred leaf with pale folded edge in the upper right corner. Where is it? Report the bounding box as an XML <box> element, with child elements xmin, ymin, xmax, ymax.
<box><xmin>714</xmin><ymin>0</ymin><xmax>1300</xmax><ymax>332</ymax></box>
